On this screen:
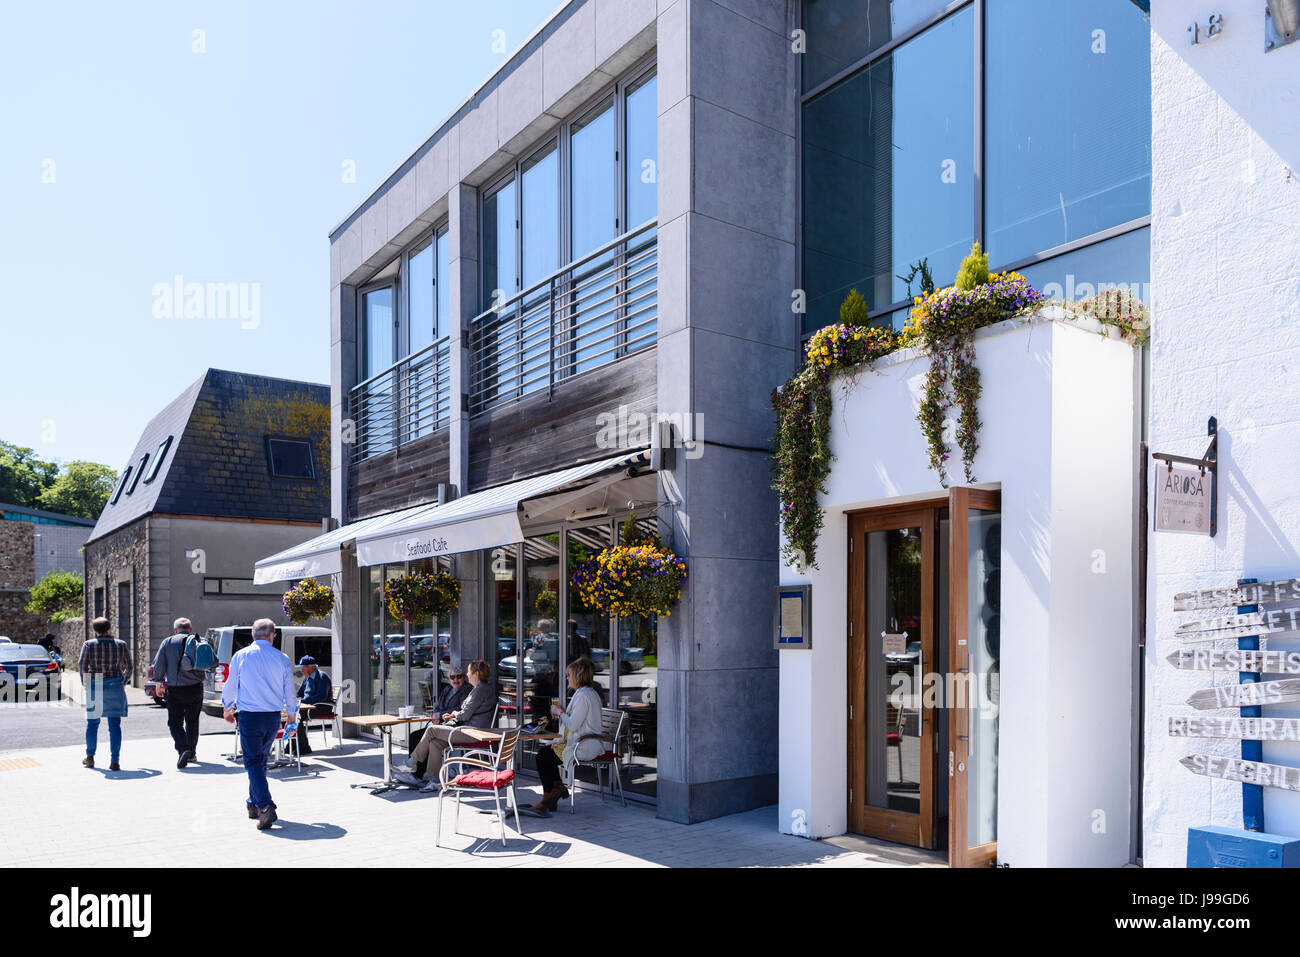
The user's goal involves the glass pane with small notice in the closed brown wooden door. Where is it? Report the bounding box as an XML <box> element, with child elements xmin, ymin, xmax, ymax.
<box><xmin>863</xmin><ymin>528</ymin><xmax>923</xmax><ymax>814</ymax></box>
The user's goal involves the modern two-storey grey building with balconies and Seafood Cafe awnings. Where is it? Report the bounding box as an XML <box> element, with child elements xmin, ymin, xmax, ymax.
<box><xmin>257</xmin><ymin>0</ymin><xmax>800</xmax><ymax>822</ymax></box>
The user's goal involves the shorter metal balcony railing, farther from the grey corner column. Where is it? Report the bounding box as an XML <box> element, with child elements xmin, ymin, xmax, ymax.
<box><xmin>348</xmin><ymin>338</ymin><xmax>451</xmax><ymax>463</ymax></box>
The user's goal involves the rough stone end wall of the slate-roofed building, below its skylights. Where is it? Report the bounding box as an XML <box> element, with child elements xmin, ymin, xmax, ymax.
<box><xmin>82</xmin><ymin>519</ymin><xmax>152</xmax><ymax>688</ymax></box>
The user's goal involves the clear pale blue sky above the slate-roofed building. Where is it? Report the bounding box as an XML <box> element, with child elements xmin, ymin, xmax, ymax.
<box><xmin>0</xmin><ymin>0</ymin><xmax>560</xmax><ymax>471</ymax></box>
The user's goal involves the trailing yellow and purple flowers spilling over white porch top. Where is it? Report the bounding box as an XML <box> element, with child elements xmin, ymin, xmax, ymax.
<box><xmin>772</xmin><ymin>243</ymin><xmax>1147</xmax><ymax>567</ymax></box>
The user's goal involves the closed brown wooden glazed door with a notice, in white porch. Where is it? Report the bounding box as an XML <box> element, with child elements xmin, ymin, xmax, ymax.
<box><xmin>848</xmin><ymin>506</ymin><xmax>946</xmax><ymax>848</ymax></box>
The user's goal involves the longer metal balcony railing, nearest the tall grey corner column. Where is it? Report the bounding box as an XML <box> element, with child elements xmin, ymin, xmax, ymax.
<box><xmin>468</xmin><ymin>220</ymin><xmax>659</xmax><ymax>413</ymax></box>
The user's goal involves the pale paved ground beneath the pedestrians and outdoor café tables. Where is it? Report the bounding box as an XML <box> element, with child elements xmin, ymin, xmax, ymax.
<box><xmin>0</xmin><ymin>735</ymin><xmax>936</xmax><ymax>867</ymax></box>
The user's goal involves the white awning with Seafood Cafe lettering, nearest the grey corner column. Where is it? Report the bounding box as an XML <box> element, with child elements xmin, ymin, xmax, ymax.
<box><xmin>355</xmin><ymin>450</ymin><xmax>650</xmax><ymax>566</ymax></box>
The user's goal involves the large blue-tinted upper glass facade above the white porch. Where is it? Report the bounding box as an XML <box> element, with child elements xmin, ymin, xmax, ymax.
<box><xmin>802</xmin><ymin>0</ymin><xmax>1151</xmax><ymax>333</ymax></box>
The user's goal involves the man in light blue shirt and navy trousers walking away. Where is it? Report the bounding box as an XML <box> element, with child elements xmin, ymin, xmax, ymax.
<box><xmin>221</xmin><ymin>618</ymin><xmax>298</xmax><ymax>831</ymax></box>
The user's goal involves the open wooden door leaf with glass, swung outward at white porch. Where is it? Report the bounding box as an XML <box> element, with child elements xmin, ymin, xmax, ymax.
<box><xmin>948</xmin><ymin>489</ymin><xmax>1002</xmax><ymax>867</ymax></box>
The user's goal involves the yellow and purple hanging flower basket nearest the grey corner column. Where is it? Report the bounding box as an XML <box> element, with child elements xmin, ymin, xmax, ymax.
<box><xmin>572</xmin><ymin>516</ymin><xmax>686</xmax><ymax>618</ymax></box>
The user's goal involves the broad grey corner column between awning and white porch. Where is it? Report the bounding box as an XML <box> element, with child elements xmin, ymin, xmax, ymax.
<box><xmin>658</xmin><ymin>0</ymin><xmax>798</xmax><ymax>823</ymax></box>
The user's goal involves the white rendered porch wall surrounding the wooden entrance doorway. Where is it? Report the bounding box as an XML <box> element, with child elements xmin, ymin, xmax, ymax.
<box><xmin>780</xmin><ymin>320</ymin><xmax>1138</xmax><ymax>866</ymax></box>
